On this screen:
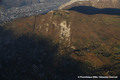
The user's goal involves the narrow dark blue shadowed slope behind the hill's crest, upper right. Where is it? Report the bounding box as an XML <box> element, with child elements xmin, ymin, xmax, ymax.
<box><xmin>69</xmin><ymin>6</ymin><xmax>120</xmax><ymax>15</ymax></box>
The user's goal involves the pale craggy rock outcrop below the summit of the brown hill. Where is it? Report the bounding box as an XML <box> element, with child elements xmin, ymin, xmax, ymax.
<box><xmin>35</xmin><ymin>11</ymin><xmax>71</xmax><ymax>46</ymax></box>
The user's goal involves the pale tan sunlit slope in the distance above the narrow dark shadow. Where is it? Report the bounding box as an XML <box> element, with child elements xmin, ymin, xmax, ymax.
<box><xmin>59</xmin><ymin>0</ymin><xmax>120</xmax><ymax>9</ymax></box>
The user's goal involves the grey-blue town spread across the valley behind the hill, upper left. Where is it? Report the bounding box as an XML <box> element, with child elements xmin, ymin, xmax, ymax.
<box><xmin>0</xmin><ymin>2</ymin><xmax>63</xmax><ymax>23</ymax></box>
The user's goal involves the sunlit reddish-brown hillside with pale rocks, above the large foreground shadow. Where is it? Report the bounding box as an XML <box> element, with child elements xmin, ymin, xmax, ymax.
<box><xmin>2</xmin><ymin>10</ymin><xmax>120</xmax><ymax>78</ymax></box>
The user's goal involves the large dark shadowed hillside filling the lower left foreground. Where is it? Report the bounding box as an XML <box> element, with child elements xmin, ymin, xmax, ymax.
<box><xmin>0</xmin><ymin>26</ymin><xmax>96</xmax><ymax>80</ymax></box>
